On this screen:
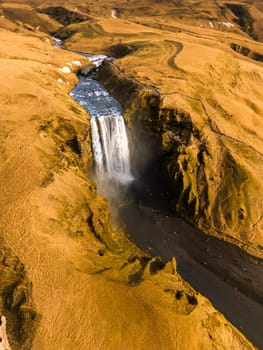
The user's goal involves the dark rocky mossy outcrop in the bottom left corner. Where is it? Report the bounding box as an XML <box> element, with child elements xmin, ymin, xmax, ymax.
<box><xmin>0</xmin><ymin>243</ymin><xmax>38</xmax><ymax>350</ymax></box>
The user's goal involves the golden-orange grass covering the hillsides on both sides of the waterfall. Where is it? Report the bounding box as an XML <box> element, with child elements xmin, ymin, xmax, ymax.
<box><xmin>0</xmin><ymin>0</ymin><xmax>263</xmax><ymax>350</ymax></box>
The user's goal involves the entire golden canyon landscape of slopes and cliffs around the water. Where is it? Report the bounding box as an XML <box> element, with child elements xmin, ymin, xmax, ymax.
<box><xmin>0</xmin><ymin>1</ymin><xmax>263</xmax><ymax>350</ymax></box>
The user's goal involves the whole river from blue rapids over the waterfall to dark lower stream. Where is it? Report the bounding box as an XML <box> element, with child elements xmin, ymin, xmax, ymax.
<box><xmin>70</xmin><ymin>47</ymin><xmax>263</xmax><ymax>349</ymax></box>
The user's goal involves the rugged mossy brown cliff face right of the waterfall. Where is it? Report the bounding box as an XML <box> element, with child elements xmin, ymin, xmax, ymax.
<box><xmin>98</xmin><ymin>50</ymin><xmax>263</xmax><ymax>258</ymax></box>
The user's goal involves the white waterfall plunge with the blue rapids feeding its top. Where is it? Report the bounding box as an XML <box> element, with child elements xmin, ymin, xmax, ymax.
<box><xmin>70</xmin><ymin>55</ymin><xmax>133</xmax><ymax>184</ymax></box>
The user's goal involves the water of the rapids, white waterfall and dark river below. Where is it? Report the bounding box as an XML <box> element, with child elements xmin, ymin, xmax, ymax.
<box><xmin>64</xmin><ymin>44</ymin><xmax>263</xmax><ymax>349</ymax></box>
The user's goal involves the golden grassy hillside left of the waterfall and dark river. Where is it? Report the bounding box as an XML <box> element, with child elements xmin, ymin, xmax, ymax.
<box><xmin>0</xmin><ymin>7</ymin><xmax>258</xmax><ymax>350</ymax></box>
